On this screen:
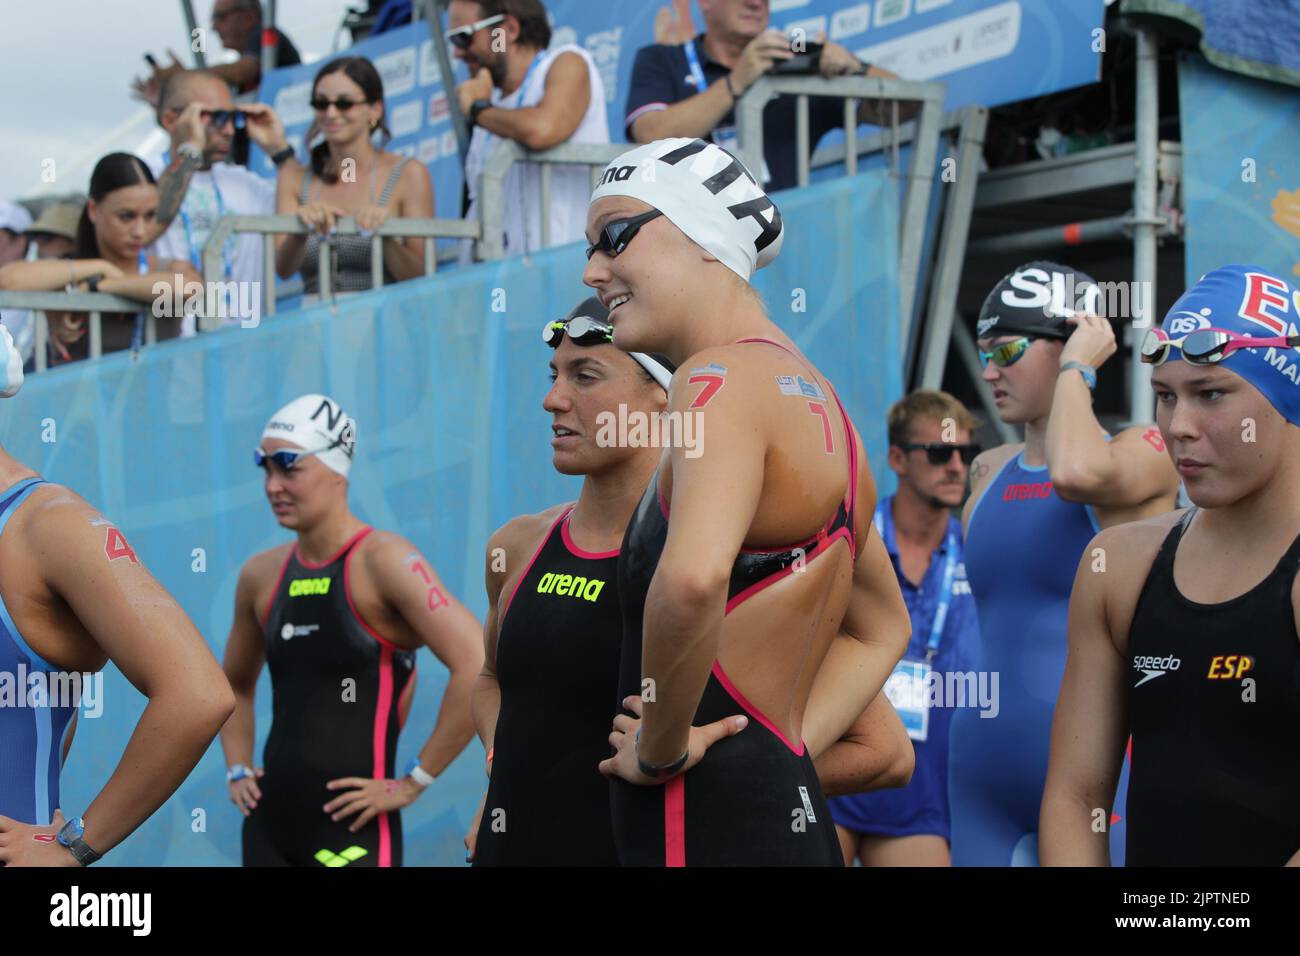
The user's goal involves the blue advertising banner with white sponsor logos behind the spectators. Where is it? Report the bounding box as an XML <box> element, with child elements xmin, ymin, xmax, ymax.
<box><xmin>250</xmin><ymin>0</ymin><xmax>1105</xmax><ymax>217</ymax></box>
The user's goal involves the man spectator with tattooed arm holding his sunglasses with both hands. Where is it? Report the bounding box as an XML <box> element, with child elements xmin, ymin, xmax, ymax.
<box><xmin>150</xmin><ymin>70</ymin><xmax>296</xmax><ymax>336</ymax></box>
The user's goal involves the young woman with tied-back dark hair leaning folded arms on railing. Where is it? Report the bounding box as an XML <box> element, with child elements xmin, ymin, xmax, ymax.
<box><xmin>0</xmin><ymin>152</ymin><xmax>202</xmax><ymax>364</ymax></box>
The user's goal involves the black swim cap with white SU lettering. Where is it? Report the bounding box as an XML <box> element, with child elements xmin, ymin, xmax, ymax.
<box><xmin>975</xmin><ymin>260</ymin><xmax>1101</xmax><ymax>339</ymax></box>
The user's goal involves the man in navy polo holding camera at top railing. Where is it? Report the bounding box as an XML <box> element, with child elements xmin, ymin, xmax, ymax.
<box><xmin>624</xmin><ymin>0</ymin><xmax>906</xmax><ymax>193</ymax></box>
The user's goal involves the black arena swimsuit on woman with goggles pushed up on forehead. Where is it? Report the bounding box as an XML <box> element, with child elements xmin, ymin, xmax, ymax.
<box><xmin>475</xmin><ymin>509</ymin><xmax>620</xmax><ymax>866</ymax></box>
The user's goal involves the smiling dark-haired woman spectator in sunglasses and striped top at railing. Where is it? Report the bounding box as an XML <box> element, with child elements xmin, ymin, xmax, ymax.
<box><xmin>276</xmin><ymin>56</ymin><xmax>434</xmax><ymax>302</ymax></box>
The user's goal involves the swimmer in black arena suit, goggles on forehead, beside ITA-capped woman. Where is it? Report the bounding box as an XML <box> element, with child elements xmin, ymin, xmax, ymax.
<box><xmin>465</xmin><ymin>297</ymin><xmax>911</xmax><ymax>866</ymax></box>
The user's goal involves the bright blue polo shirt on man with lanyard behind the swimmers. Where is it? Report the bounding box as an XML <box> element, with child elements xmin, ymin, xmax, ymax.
<box><xmin>831</xmin><ymin>496</ymin><xmax>979</xmax><ymax>840</ymax></box>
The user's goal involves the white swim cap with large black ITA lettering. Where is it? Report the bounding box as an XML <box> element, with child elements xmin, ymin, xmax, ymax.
<box><xmin>592</xmin><ymin>139</ymin><xmax>785</xmax><ymax>282</ymax></box>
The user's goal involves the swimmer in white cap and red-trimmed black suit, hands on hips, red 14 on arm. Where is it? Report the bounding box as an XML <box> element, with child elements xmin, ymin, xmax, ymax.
<box><xmin>221</xmin><ymin>395</ymin><xmax>482</xmax><ymax>866</ymax></box>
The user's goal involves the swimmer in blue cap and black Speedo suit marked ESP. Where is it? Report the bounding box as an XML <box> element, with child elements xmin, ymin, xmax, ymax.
<box><xmin>1043</xmin><ymin>265</ymin><xmax>1300</xmax><ymax>866</ymax></box>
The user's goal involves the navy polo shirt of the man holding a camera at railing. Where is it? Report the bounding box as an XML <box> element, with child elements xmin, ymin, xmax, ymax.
<box><xmin>623</xmin><ymin>34</ymin><xmax>844</xmax><ymax>193</ymax></box>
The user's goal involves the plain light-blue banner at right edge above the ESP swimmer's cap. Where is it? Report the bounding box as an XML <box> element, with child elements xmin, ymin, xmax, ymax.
<box><xmin>1178</xmin><ymin>55</ymin><xmax>1300</xmax><ymax>285</ymax></box>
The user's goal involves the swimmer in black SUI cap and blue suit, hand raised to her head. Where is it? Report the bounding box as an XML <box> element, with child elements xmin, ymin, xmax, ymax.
<box><xmin>949</xmin><ymin>261</ymin><xmax>1178</xmax><ymax>866</ymax></box>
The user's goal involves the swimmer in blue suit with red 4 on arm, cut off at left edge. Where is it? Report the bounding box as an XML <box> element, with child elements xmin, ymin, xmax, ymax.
<box><xmin>0</xmin><ymin>343</ymin><xmax>234</xmax><ymax>868</ymax></box>
